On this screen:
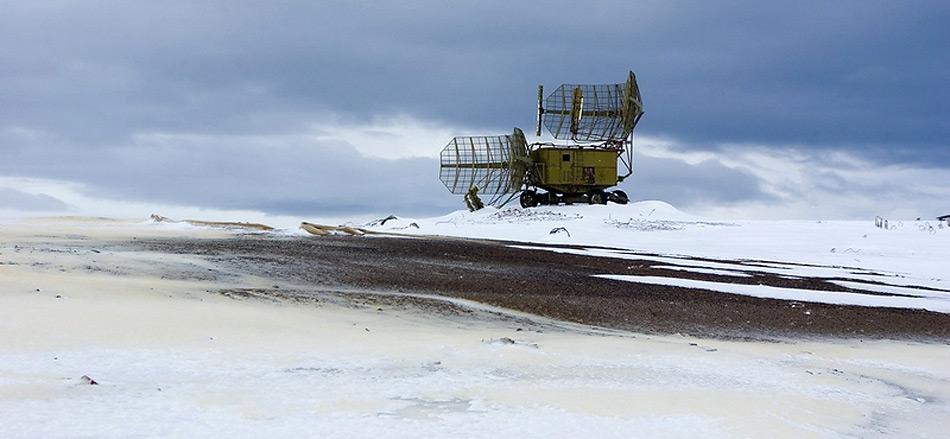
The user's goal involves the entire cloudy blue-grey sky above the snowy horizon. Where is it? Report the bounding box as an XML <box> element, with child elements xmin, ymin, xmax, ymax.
<box><xmin>0</xmin><ymin>0</ymin><xmax>950</xmax><ymax>219</ymax></box>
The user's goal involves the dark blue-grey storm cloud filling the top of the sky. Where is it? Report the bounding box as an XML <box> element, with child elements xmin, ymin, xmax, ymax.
<box><xmin>0</xmin><ymin>1</ymin><xmax>950</xmax><ymax>159</ymax></box>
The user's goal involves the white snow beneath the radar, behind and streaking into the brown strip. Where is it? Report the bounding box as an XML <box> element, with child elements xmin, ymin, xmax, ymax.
<box><xmin>364</xmin><ymin>201</ymin><xmax>950</xmax><ymax>312</ymax></box>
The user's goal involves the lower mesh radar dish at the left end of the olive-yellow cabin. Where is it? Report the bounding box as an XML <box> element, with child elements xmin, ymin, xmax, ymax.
<box><xmin>439</xmin><ymin>128</ymin><xmax>529</xmax><ymax>204</ymax></box>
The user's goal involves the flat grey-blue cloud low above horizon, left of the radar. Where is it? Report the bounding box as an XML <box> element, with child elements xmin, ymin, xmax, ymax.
<box><xmin>0</xmin><ymin>124</ymin><xmax>459</xmax><ymax>214</ymax></box>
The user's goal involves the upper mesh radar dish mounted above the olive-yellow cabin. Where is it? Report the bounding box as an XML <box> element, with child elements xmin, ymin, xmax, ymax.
<box><xmin>536</xmin><ymin>72</ymin><xmax>643</xmax><ymax>142</ymax></box>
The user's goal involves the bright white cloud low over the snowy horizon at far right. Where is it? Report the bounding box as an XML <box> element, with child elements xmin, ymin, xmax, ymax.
<box><xmin>668</xmin><ymin>145</ymin><xmax>950</xmax><ymax>219</ymax></box>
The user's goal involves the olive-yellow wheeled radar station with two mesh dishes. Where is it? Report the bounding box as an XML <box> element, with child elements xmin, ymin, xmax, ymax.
<box><xmin>439</xmin><ymin>72</ymin><xmax>643</xmax><ymax>210</ymax></box>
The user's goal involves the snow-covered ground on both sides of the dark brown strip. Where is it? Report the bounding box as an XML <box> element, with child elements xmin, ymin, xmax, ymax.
<box><xmin>0</xmin><ymin>214</ymin><xmax>950</xmax><ymax>437</ymax></box>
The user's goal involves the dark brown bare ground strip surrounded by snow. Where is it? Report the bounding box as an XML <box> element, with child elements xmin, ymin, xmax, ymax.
<box><xmin>134</xmin><ymin>236</ymin><xmax>950</xmax><ymax>342</ymax></box>
